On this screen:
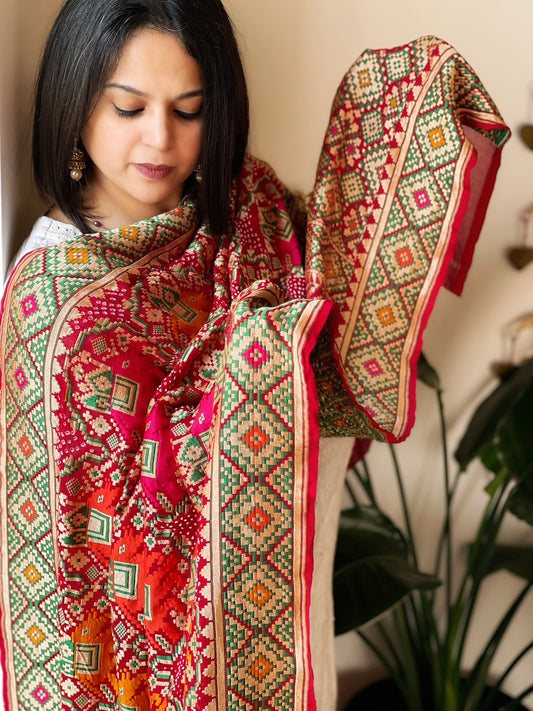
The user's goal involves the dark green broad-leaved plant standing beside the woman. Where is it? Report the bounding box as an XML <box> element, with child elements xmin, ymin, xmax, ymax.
<box><xmin>334</xmin><ymin>356</ymin><xmax>533</xmax><ymax>711</ymax></box>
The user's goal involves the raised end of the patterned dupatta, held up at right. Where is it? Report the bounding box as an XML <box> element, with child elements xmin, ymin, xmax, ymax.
<box><xmin>307</xmin><ymin>37</ymin><xmax>509</xmax><ymax>441</ymax></box>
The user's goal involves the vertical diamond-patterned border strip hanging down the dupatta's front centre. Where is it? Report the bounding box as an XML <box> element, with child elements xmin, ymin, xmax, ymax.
<box><xmin>218</xmin><ymin>301</ymin><xmax>324</xmax><ymax>708</ymax></box>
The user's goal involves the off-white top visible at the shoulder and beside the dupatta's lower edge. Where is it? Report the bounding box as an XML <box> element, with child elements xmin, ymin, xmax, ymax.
<box><xmin>13</xmin><ymin>216</ymin><xmax>353</xmax><ymax>711</ymax></box>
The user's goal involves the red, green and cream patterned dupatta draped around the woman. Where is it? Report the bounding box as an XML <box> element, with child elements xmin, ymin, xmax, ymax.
<box><xmin>0</xmin><ymin>37</ymin><xmax>509</xmax><ymax>711</ymax></box>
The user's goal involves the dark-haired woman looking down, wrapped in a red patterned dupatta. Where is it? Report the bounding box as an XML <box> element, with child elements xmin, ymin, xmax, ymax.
<box><xmin>0</xmin><ymin>0</ymin><xmax>508</xmax><ymax>711</ymax></box>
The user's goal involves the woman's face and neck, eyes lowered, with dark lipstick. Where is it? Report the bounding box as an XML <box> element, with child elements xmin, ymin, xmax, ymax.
<box><xmin>81</xmin><ymin>29</ymin><xmax>203</xmax><ymax>227</ymax></box>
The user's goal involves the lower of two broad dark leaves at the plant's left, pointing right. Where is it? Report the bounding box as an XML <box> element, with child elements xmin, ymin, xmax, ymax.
<box><xmin>333</xmin><ymin>555</ymin><xmax>440</xmax><ymax>634</ymax></box>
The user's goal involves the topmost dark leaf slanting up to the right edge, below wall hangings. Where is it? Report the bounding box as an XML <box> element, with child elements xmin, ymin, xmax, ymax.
<box><xmin>455</xmin><ymin>358</ymin><xmax>533</xmax><ymax>470</ymax></box>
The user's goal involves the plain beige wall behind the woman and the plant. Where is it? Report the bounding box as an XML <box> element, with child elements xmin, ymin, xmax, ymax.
<box><xmin>0</xmin><ymin>0</ymin><xmax>533</xmax><ymax>708</ymax></box>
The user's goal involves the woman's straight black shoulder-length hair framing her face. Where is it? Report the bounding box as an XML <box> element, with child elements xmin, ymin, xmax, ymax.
<box><xmin>33</xmin><ymin>0</ymin><xmax>248</xmax><ymax>234</ymax></box>
